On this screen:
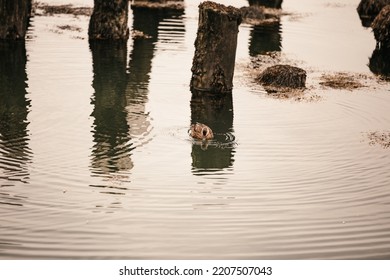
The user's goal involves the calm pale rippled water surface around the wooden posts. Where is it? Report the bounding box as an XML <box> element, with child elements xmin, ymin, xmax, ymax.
<box><xmin>0</xmin><ymin>0</ymin><xmax>390</xmax><ymax>259</ymax></box>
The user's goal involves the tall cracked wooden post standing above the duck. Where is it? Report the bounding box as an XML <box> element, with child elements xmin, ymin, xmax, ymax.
<box><xmin>191</xmin><ymin>1</ymin><xmax>241</xmax><ymax>93</ymax></box>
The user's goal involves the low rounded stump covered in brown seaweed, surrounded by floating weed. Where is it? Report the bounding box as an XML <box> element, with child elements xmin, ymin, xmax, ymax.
<box><xmin>258</xmin><ymin>65</ymin><xmax>306</xmax><ymax>88</ymax></box>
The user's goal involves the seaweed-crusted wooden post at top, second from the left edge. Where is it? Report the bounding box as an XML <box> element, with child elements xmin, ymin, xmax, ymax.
<box><xmin>88</xmin><ymin>0</ymin><xmax>129</xmax><ymax>40</ymax></box>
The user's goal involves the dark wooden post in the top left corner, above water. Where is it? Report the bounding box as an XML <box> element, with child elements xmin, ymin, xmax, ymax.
<box><xmin>0</xmin><ymin>0</ymin><xmax>31</xmax><ymax>40</ymax></box>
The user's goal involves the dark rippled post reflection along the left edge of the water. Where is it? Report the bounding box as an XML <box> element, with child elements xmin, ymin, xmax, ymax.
<box><xmin>0</xmin><ymin>41</ymin><xmax>31</xmax><ymax>187</ymax></box>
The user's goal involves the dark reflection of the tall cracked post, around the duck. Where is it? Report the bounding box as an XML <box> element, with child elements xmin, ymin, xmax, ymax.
<box><xmin>191</xmin><ymin>91</ymin><xmax>234</xmax><ymax>174</ymax></box>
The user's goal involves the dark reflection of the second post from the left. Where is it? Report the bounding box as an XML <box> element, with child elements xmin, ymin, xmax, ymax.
<box><xmin>90</xmin><ymin>40</ymin><xmax>133</xmax><ymax>174</ymax></box>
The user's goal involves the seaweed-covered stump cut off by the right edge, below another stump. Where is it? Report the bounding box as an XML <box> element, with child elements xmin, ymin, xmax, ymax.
<box><xmin>371</xmin><ymin>5</ymin><xmax>390</xmax><ymax>49</ymax></box>
